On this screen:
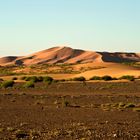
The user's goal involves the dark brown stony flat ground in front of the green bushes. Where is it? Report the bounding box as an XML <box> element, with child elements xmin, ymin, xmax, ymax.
<box><xmin>0</xmin><ymin>81</ymin><xmax>140</xmax><ymax>140</ymax></box>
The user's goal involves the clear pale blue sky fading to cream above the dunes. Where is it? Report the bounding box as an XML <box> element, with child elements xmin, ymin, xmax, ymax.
<box><xmin>0</xmin><ymin>0</ymin><xmax>140</xmax><ymax>56</ymax></box>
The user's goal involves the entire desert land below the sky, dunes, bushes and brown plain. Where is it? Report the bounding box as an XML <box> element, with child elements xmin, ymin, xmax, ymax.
<box><xmin>0</xmin><ymin>47</ymin><xmax>140</xmax><ymax>140</ymax></box>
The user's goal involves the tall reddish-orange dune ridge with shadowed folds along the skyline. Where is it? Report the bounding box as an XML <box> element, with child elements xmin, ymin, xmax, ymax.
<box><xmin>0</xmin><ymin>46</ymin><xmax>140</xmax><ymax>65</ymax></box>
